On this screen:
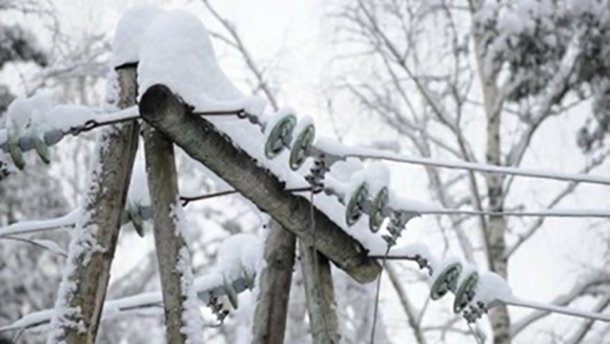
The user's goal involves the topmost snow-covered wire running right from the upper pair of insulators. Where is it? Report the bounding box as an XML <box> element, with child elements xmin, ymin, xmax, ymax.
<box><xmin>316</xmin><ymin>140</ymin><xmax>610</xmax><ymax>185</ymax></box>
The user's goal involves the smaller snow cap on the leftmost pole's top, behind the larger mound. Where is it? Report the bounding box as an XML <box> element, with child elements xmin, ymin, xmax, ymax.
<box><xmin>112</xmin><ymin>5</ymin><xmax>163</xmax><ymax>67</ymax></box>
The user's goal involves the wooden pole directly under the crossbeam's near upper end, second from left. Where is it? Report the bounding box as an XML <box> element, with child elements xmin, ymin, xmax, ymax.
<box><xmin>144</xmin><ymin>124</ymin><xmax>200</xmax><ymax>344</ymax></box>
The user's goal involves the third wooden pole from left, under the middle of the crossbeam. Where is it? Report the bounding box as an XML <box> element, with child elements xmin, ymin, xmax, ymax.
<box><xmin>252</xmin><ymin>220</ymin><xmax>296</xmax><ymax>344</ymax></box>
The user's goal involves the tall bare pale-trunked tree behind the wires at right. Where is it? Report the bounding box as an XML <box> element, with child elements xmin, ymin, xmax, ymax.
<box><xmin>332</xmin><ymin>0</ymin><xmax>609</xmax><ymax>344</ymax></box>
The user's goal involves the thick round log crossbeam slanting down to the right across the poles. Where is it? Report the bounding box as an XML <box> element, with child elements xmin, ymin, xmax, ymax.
<box><xmin>139</xmin><ymin>85</ymin><xmax>381</xmax><ymax>283</ymax></box>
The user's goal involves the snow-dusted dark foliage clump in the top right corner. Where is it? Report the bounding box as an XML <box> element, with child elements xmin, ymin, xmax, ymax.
<box><xmin>474</xmin><ymin>0</ymin><xmax>610</xmax><ymax>152</ymax></box>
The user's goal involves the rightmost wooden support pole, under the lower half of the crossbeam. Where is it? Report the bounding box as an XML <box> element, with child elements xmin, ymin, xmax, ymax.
<box><xmin>299</xmin><ymin>241</ymin><xmax>339</xmax><ymax>344</ymax></box>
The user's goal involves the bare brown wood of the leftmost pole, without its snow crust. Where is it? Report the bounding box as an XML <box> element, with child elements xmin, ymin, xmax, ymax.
<box><xmin>54</xmin><ymin>67</ymin><xmax>138</xmax><ymax>344</ymax></box>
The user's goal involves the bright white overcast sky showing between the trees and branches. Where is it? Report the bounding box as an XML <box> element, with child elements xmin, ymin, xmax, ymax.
<box><xmin>2</xmin><ymin>0</ymin><xmax>610</xmax><ymax>343</ymax></box>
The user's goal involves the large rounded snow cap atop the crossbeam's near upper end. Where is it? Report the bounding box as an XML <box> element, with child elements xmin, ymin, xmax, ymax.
<box><xmin>138</xmin><ymin>10</ymin><xmax>259</xmax><ymax>111</ymax></box>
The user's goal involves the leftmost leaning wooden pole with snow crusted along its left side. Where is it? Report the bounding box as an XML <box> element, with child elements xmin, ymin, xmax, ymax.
<box><xmin>48</xmin><ymin>67</ymin><xmax>138</xmax><ymax>344</ymax></box>
